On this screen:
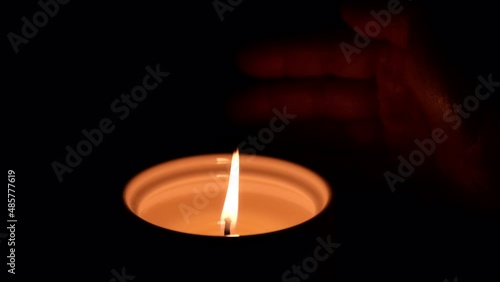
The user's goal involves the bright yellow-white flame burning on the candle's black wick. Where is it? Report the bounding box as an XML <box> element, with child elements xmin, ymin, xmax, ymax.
<box><xmin>220</xmin><ymin>149</ymin><xmax>240</xmax><ymax>235</ymax></box>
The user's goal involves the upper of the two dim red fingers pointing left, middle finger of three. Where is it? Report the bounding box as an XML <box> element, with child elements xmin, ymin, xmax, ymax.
<box><xmin>237</xmin><ymin>32</ymin><xmax>377</xmax><ymax>79</ymax></box>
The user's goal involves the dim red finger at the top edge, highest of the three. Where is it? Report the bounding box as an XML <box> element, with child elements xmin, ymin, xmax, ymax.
<box><xmin>341</xmin><ymin>1</ymin><xmax>415</xmax><ymax>48</ymax></box>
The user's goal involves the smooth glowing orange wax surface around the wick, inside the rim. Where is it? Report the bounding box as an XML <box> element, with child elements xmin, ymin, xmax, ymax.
<box><xmin>140</xmin><ymin>181</ymin><xmax>316</xmax><ymax>236</ymax></box>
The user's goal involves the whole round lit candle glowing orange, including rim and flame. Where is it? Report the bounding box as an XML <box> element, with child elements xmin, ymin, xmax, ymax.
<box><xmin>123</xmin><ymin>151</ymin><xmax>331</xmax><ymax>237</ymax></box>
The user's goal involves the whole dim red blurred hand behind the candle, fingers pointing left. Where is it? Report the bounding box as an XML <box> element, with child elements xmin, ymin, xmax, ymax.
<box><xmin>229</xmin><ymin>1</ymin><xmax>500</xmax><ymax>212</ymax></box>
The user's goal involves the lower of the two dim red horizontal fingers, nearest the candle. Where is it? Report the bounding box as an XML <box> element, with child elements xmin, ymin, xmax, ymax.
<box><xmin>228</xmin><ymin>79</ymin><xmax>378</xmax><ymax>121</ymax></box>
